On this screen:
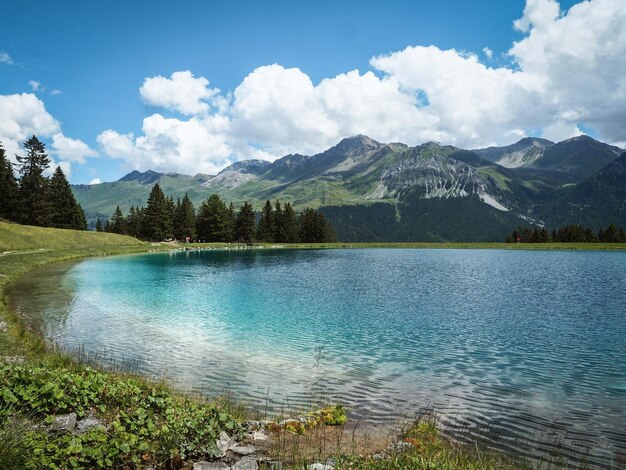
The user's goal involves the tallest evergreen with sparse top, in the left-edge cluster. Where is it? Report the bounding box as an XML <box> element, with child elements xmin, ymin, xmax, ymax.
<box><xmin>16</xmin><ymin>135</ymin><xmax>51</xmax><ymax>226</ymax></box>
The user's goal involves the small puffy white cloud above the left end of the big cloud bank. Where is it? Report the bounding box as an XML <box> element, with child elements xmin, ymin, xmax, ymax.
<box><xmin>139</xmin><ymin>70</ymin><xmax>219</xmax><ymax>115</ymax></box>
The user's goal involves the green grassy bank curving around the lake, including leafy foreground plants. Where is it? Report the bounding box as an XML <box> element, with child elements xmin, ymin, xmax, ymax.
<box><xmin>0</xmin><ymin>222</ymin><xmax>626</xmax><ymax>469</ymax></box>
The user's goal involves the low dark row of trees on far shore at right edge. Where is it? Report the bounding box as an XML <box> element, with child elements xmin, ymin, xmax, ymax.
<box><xmin>506</xmin><ymin>224</ymin><xmax>626</xmax><ymax>243</ymax></box>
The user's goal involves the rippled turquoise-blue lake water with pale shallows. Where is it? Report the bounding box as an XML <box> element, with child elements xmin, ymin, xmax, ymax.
<box><xmin>9</xmin><ymin>249</ymin><xmax>626</xmax><ymax>466</ymax></box>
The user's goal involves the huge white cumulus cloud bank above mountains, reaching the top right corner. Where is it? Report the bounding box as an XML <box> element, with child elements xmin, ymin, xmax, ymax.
<box><xmin>98</xmin><ymin>0</ymin><xmax>626</xmax><ymax>173</ymax></box>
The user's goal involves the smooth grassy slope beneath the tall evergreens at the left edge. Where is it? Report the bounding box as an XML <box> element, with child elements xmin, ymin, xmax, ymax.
<box><xmin>0</xmin><ymin>221</ymin><xmax>148</xmax><ymax>253</ymax></box>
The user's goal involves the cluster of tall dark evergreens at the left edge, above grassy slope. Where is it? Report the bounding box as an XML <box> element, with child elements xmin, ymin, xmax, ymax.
<box><xmin>0</xmin><ymin>135</ymin><xmax>87</xmax><ymax>230</ymax></box>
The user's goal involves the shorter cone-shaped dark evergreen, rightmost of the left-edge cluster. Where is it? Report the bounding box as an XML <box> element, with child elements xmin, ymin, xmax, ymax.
<box><xmin>48</xmin><ymin>166</ymin><xmax>87</xmax><ymax>230</ymax></box>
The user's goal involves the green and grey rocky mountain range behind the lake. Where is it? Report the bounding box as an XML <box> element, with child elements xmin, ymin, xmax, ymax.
<box><xmin>72</xmin><ymin>135</ymin><xmax>626</xmax><ymax>241</ymax></box>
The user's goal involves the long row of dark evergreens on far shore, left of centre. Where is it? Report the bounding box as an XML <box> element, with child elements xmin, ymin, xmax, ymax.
<box><xmin>96</xmin><ymin>183</ymin><xmax>335</xmax><ymax>243</ymax></box>
